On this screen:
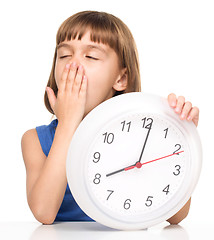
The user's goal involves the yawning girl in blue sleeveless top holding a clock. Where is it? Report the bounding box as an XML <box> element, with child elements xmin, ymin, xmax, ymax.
<box><xmin>21</xmin><ymin>11</ymin><xmax>199</xmax><ymax>224</ymax></box>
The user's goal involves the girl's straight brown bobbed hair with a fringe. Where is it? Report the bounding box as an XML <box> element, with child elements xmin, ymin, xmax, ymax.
<box><xmin>44</xmin><ymin>11</ymin><xmax>141</xmax><ymax>114</ymax></box>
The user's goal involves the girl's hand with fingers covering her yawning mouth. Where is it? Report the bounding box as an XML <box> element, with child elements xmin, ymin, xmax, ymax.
<box><xmin>46</xmin><ymin>63</ymin><xmax>87</xmax><ymax>129</ymax></box>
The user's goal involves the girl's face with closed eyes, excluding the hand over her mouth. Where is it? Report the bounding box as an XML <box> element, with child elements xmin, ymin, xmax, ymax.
<box><xmin>55</xmin><ymin>31</ymin><xmax>127</xmax><ymax>115</ymax></box>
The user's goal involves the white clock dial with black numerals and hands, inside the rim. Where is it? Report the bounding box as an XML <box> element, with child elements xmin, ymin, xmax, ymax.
<box><xmin>85</xmin><ymin>112</ymin><xmax>190</xmax><ymax>222</ymax></box>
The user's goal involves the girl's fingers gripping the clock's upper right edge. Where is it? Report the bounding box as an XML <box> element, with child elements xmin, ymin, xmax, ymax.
<box><xmin>168</xmin><ymin>93</ymin><xmax>199</xmax><ymax>127</ymax></box>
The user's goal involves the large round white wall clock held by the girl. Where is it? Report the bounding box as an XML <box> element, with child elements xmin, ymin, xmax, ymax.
<box><xmin>66</xmin><ymin>92</ymin><xmax>202</xmax><ymax>230</ymax></box>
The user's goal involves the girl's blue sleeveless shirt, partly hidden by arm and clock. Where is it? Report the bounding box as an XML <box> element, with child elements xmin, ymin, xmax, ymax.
<box><xmin>36</xmin><ymin>119</ymin><xmax>94</xmax><ymax>222</ymax></box>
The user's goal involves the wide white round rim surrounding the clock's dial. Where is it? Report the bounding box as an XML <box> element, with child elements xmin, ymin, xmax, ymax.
<box><xmin>66</xmin><ymin>92</ymin><xmax>202</xmax><ymax>230</ymax></box>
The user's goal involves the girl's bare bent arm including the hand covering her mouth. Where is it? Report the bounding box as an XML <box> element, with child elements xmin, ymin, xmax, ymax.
<box><xmin>21</xmin><ymin>62</ymin><xmax>87</xmax><ymax>224</ymax></box>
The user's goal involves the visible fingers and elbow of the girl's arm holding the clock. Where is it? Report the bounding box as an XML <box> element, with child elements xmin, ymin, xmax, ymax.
<box><xmin>167</xmin><ymin>93</ymin><xmax>199</xmax><ymax>224</ymax></box>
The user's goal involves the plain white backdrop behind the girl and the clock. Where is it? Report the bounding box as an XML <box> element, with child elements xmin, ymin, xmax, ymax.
<box><xmin>0</xmin><ymin>0</ymin><xmax>214</xmax><ymax>225</ymax></box>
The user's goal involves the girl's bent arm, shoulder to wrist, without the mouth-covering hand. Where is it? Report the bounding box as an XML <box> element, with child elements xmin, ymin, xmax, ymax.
<box><xmin>21</xmin><ymin>126</ymin><xmax>72</xmax><ymax>224</ymax></box>
